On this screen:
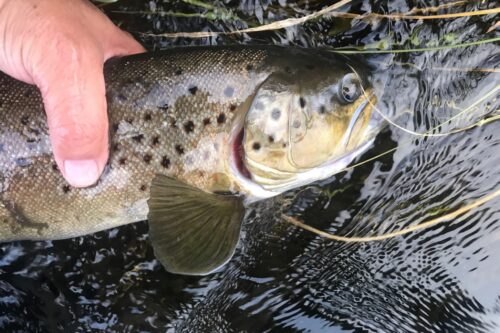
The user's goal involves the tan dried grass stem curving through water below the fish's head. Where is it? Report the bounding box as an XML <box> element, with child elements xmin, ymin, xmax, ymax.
<box><xmin>281</xmin><ymin>189</ymin><xmax>500</xmax><ymax>243</ymax></box>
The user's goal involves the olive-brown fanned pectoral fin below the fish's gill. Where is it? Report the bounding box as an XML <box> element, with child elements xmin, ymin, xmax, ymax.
<box><xmin>148</xmin><ymin>175</ymin><xmax>245</xmax><ymax>275</ymax></box>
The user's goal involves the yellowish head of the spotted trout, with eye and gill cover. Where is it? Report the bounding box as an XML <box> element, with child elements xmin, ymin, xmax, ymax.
<box><xmin>235</xmin><ymin>59</ymin><xmax>375</xmax><ymax>198</ymax></box>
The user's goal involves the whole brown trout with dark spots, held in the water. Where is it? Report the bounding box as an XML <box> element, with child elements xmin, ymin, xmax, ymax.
<box><xmin>0</xmin><ymin>46</ymin><xmax>380</xmax><ymax>275</ymax></box>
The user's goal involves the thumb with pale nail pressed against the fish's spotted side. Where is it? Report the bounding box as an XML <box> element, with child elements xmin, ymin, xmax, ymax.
<box><xmin>34</xmin><ymin>38</ymin><xmax>108</xmax><ymax>187</ymax></box>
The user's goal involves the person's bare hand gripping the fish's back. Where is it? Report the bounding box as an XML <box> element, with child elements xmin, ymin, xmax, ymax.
<box><xmin>0</xmin><ymin>0</ymin><xmax>144</xmax><ymax>187</ymax></box>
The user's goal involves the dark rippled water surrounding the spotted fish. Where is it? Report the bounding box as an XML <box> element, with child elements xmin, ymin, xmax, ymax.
<box><xmin>0</xmin><ymin>0</ymin><xmax>500</xmax><ymax>332</ymax></box>
